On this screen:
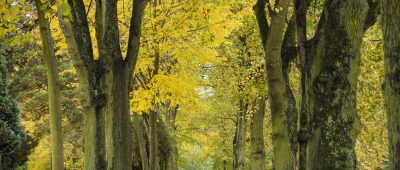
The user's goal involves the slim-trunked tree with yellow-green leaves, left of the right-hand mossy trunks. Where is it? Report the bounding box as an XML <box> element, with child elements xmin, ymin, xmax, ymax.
<box><xmin>207</xmin><ymin>13</ymin><xmax>266</xmax><ymax>169</ymax></box>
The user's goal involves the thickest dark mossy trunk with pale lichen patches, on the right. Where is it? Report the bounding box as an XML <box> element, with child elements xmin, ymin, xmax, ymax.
<box><xmin>307</xmin><ymin>0</ymin><xmax>368</xmax><ymax>170</ymax></box>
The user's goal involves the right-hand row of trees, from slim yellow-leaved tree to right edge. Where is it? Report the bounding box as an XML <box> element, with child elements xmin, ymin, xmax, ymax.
<box><xmin>208</xmin><ymin>0</ymin><xmax>399</xmax><ymax>169</ymax></box>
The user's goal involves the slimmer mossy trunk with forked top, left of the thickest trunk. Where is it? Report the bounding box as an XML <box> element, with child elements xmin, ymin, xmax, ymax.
<box><xmin>254</xmin><ymin>0</ymin><xmax>297</xmax><ymax>169</ymax></box>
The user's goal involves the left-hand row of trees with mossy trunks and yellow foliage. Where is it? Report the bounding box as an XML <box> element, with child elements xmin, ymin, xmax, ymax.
<box><xmin>30</xmin><ymin>1</ymin><xmax>241</xmax><ymax>169</ymax></box>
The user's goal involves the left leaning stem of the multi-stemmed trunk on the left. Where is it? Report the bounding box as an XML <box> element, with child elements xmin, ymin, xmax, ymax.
<box><xmin>58</xmin><ymin>0</ymin><xmax>107</xmax><ymax>170</ymax></box>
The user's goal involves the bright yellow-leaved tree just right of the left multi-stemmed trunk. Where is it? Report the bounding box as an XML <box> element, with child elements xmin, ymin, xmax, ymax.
<box><xmin>130</xmin><ymin>0</ymin><xmax>245</xmax><ymax>169</ymax></box>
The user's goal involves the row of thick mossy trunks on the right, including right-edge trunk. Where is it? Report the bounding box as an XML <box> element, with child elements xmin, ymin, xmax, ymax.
<box><xmin>252</xmin><ymin>0</ymin><xmax>399</xmax><ymax>169</ymax></box>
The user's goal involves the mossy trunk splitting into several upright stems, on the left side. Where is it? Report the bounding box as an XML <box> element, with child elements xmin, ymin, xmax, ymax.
<box><xmin>59</xmin><ymin>0</ymin><xmax>147</xmax><ymax>170</ymax></box>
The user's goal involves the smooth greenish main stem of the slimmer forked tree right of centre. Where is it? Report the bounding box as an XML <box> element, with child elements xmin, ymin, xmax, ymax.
<box><xmin>260</xmin><ymin>0</ymin><xmax>295</xmax><ymax>170</ymax></box>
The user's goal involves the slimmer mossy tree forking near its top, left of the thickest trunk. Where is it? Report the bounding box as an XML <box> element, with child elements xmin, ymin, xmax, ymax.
<box><xmin>254</xmin><ymin>0</ymin><xmax>296</xmax><ymax>169</ymax></box>
